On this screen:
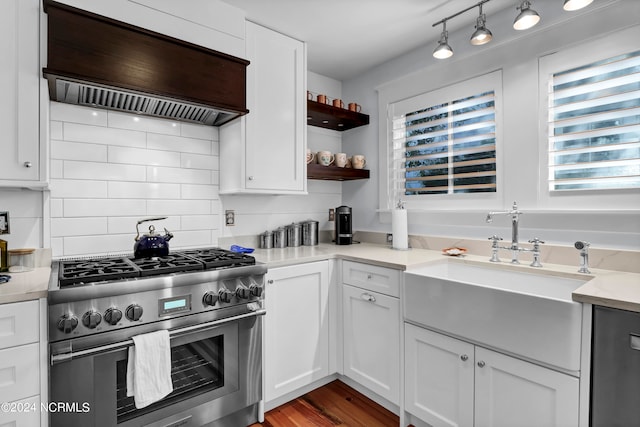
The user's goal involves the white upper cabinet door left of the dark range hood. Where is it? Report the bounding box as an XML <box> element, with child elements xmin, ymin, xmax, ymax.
<box><xmin>0</xmin><ymin>0</ymin><xmax>40</xmax><ymax>186</ymax></box>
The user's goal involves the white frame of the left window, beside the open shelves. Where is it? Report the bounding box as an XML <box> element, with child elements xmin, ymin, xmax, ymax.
<box><xmin>380</xmin><ymin>70</ymin><xmax>504</xmax><ymax>211</ymax></box>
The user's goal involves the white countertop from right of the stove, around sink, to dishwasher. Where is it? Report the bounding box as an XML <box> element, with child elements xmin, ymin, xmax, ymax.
<box><xmin>252</xmin><ymin>243</ymin><xmax>640</xmax><ymax>312</ymax></box>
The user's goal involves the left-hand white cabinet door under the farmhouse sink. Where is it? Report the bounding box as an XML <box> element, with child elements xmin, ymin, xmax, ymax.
<box><xmin>405</xmin><ymin>323</ymin><xmax>474</xmax><ymax>427</ymax></box>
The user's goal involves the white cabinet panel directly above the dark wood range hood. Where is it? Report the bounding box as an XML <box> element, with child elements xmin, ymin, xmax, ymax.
<box><xmin>48</xmin><ymin>0</ymin><xmax>245</xmax><ymax>57</ymax></box>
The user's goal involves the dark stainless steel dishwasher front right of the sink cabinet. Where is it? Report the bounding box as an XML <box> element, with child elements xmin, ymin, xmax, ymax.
<box><xmin>591</xmin><ymin>306</ymin><xmax>640</xmax><ymax>427</ymax></box>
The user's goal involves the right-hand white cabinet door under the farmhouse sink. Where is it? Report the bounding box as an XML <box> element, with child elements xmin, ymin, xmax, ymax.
<box><xmin>475</xmin><ymin>347</ymin><xmax>579</xmax><ymax>427</ymax></box>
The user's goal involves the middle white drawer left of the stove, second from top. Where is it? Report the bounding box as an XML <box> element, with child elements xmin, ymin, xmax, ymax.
<box><xmin>0</xmin><ymin>343</ymin><xmax>40</xmax><ymax>402</ymax></box>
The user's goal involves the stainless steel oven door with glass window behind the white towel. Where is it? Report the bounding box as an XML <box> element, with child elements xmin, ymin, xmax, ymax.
<box><xmin>51</xmin><ymin>314</ymin><xmax>262</xmax><ymax>427</ymax></box>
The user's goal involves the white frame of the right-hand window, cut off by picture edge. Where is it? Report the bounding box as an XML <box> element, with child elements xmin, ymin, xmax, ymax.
<box><xmin>538</xmin><ymin>26</ymin><xmax>640</xmax><ymax>210</ymax></box>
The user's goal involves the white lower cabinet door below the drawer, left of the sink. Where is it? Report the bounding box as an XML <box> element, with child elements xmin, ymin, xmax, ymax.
<box><xmin>342</xmin><ymin>285</ymin><xmax>400</xmax><ymax>405</ymax></box>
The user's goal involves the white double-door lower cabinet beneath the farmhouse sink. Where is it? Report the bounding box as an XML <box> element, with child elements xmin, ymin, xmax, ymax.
<box><xmin>405</xmin><ymin>324</ymin><xmax>579</xmax><ymax>427</ymax></box>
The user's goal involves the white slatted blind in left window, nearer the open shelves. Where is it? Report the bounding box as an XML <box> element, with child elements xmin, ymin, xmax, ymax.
<box><xmin>391</xmin><ymin>91</ymin><xmax>496</xmax><ymax>195</ymax></box>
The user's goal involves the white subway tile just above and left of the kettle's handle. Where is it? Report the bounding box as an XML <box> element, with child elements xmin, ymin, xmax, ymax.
<box><xmin>63</xmin><ymin>199</ymin><xmax>147</xmax><ymax>218</ymax></box>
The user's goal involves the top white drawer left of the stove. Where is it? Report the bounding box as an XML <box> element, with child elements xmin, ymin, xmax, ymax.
<box><xmin>0</xmin><ymin>300</ymin><xmax>39</xmax><ymax>348</ymax></box>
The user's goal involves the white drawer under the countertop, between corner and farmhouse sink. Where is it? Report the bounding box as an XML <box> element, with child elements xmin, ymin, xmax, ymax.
<box><xmin>342</xmin><ymin>261</ymin><xmax>401</xmax><ymax>297</ymax></box>
